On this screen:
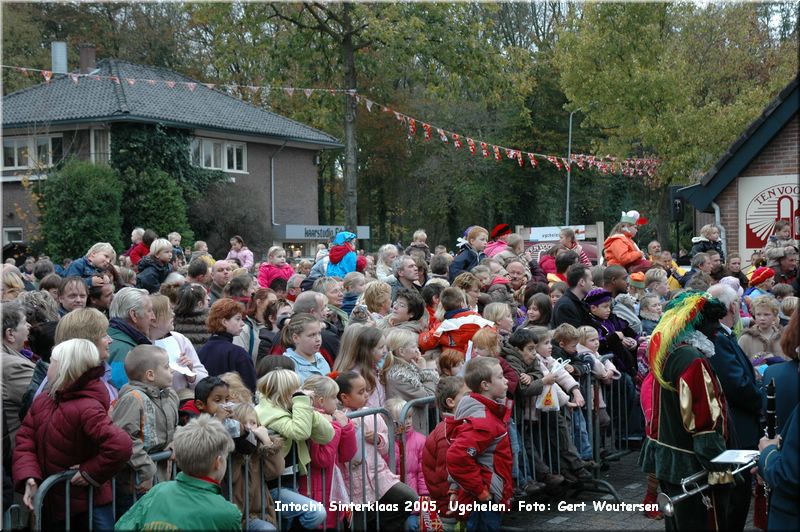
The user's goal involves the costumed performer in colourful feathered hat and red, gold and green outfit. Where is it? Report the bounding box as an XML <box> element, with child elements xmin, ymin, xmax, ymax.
<box><xmin>639</xmin><ymin>291</ymin><xmax>734</xmax><ymax>530</ymax></box>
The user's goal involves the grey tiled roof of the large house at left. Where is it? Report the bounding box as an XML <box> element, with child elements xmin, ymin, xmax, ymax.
<box><xmin>3</xmin><ymin>59</ymin><xmax>341</xmax><ymax>148</ymax></box>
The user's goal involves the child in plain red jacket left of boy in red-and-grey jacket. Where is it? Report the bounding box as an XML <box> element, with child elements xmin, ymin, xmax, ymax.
<box><xmin>422</xmin><ymin>377</ymin><xmax>469</xmax><ymax>532</ymax></box>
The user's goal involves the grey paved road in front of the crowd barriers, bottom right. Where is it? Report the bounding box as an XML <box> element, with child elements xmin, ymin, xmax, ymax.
<box><xmin>503</xmin><ymin>452</ymin><xmax>757</xmax><ymax>532</ymax></box>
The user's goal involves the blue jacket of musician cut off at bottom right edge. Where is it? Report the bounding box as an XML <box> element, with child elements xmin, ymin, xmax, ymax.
<box><xmin>758</xmin><ymin>405</ymin><xmax>800</xmax><ymax>530</ymax></box>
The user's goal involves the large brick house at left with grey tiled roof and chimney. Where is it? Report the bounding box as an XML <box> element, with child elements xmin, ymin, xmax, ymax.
<box><xmin>2</xmin><ymin>48</ymin><xmax>344</xmax><ymax>258</ymax></box>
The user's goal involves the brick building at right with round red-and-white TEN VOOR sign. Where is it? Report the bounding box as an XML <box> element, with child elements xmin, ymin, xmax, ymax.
<box><xmin>678</xmin><ymin>77</ymin><xmax>800</xmax><ymax>264</ymax></box>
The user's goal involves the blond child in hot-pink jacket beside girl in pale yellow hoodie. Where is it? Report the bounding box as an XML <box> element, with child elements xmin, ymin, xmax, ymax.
<box><xmin>298</xmin><ymin>375</ymin><xmax>358</xmax><ymax>530</ymax></box>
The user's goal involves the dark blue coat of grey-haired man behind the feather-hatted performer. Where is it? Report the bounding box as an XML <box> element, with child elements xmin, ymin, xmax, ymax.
<box><xmin>708</xmin><ymin>326</ymin><xmax>763</xmax><ymax>449</ymax></box>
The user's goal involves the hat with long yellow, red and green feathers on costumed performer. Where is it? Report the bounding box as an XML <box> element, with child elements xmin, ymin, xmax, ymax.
<box><xmin>647</xmin><ymin>290</ymin><xmax>728</xmax><ymax>391</ymax></box>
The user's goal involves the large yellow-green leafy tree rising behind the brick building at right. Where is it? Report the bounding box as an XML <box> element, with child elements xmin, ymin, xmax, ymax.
<box><xmin>555</xmin><ymin>3</ymin><xmax>797</xmax><ymax>246</ymax></box>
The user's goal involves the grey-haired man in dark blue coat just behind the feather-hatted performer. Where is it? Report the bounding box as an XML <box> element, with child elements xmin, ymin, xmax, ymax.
<box><xmin>708</xmin><ymin>284</ymin><xmax>764</xmax><ymax>530</ymax></box>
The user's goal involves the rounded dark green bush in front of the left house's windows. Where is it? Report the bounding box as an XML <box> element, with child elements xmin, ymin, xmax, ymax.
<box><xmin>42</xmin><ymin>159</ymin><xmax>123</xmax><ymax>262</ymax></box>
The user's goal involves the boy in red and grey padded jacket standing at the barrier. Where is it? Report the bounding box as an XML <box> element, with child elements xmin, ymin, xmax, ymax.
<box><xmin>446</xmin><ymin>357</ymin><xmax>514</xmax><ymax>532</ymax></box>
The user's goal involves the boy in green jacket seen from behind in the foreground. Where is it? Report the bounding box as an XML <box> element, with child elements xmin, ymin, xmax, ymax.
<box><xmin>114</xmin><ymin>414</ymin><xmax>242</xmax><ymax>530</ymax></box>
